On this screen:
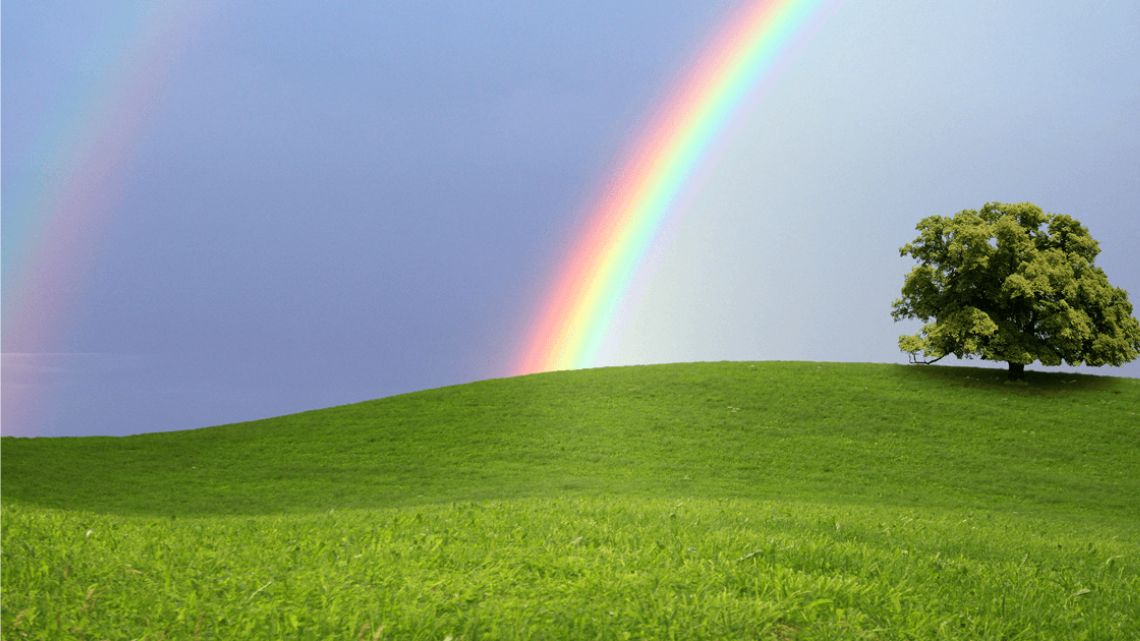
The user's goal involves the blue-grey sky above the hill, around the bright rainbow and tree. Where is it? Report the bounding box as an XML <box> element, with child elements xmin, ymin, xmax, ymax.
<box><xmin>0</xmin><ymin>0</ymin><xmax>1140</xmax><ymax>436</ymax></box>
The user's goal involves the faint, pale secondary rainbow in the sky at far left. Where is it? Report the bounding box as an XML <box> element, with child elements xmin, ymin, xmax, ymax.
<box><xmin>2</xmin><ymin>0</ymin><xmax>206</xmax><ymax>353</ymax></box>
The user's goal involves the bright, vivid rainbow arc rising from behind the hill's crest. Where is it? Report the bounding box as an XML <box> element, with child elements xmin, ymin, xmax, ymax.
<box><xmin>515</xmin><ymin>0</ymin><xmax>824</xmax><ymax>374</ymax></box>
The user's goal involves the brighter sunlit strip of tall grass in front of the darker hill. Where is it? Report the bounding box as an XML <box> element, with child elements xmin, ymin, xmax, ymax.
<box><xmin>3</xmin><ymin>497</ymin><xmax>1140</xmax><ymax>640</ymax></box>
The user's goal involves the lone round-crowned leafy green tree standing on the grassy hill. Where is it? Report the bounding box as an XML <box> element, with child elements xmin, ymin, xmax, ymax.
<box><xmin>891</xmin><ymin>203</ymin><xmax>1140</xmax><ymax>380</ymax></box>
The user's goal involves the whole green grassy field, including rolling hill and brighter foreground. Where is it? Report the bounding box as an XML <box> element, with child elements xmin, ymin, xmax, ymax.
<box><xmin>0</xmin><ymin>363</ymin><xmax>1140</xmax><ymax>641</ymax></box>
